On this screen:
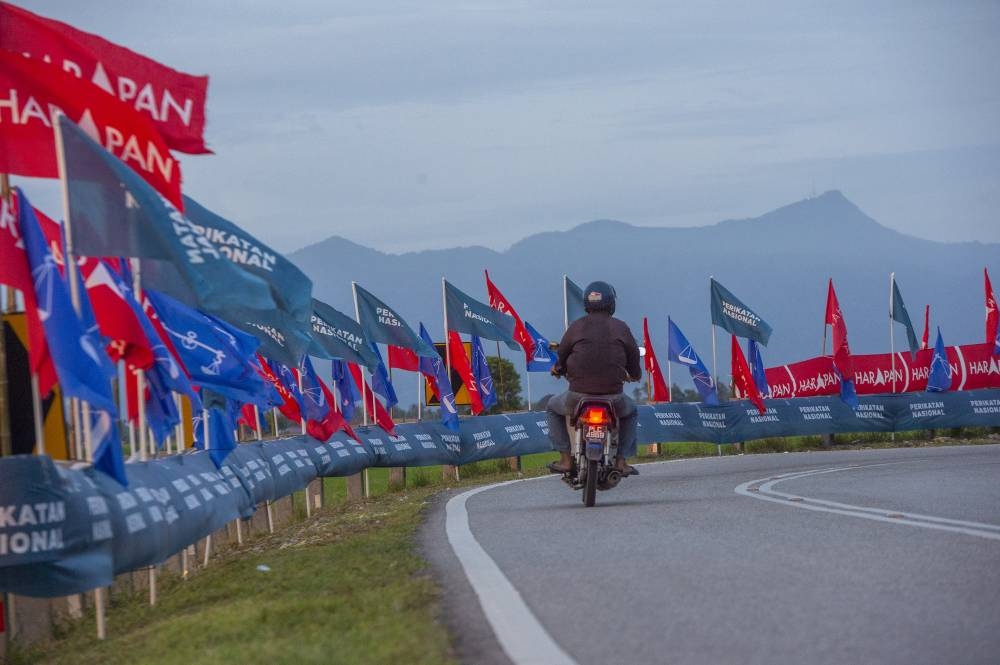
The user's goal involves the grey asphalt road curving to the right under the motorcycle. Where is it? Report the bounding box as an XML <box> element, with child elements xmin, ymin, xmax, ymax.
<box><xmin>422</xmin><ymin>445</ymin><xmax>1000</xmax><ymax>665</ymax></box>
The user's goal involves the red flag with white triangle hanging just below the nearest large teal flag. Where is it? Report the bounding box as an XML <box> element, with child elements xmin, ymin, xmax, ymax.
<box><xmin>80</xmin><ymin>258</ymin><xmax>155</xmax><ymax>369</ymax></box>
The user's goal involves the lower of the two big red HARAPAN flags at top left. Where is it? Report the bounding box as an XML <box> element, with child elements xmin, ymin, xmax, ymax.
<box><xmin>0</xmin><ymin>49</ymin><xmax>183</xmax><ymax>210</ymax></box>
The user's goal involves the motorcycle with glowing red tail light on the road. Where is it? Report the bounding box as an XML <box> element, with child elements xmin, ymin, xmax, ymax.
<box><xmin>562</xmin><ymin>397</ymin><xmax>623</xmax><ymax>508</ymax></box>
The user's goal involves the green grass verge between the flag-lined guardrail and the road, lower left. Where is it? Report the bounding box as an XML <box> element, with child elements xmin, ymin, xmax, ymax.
<box><xmin>14</xmin><ymin>490</ymin><xmax>453</xmax><ymax>665</ymax></box>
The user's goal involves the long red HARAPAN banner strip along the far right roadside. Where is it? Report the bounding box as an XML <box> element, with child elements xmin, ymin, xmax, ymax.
<box><xmin>766</xmin><ymin>344</ymin><xmax>1000</xmax><ymax>398</ymax></box>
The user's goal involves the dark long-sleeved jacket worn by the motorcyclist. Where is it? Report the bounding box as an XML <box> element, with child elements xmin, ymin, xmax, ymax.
<box><xmin>556</xmin><ymin>312</ymin><xmax>642</xmax><ymax>395</ymax></box>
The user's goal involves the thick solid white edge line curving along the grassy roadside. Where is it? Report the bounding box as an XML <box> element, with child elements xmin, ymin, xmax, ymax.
<box><xmin>445</xmin><ymin>480</ymin><xmax>577</xmax><ymax>665</ymax></box>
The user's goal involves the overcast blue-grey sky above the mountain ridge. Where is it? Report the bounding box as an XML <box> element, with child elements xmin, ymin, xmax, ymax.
<box><xmin>22</xmin><ymin>0</ymin><xmax>1000</xmax><ymax>251</ymax></box>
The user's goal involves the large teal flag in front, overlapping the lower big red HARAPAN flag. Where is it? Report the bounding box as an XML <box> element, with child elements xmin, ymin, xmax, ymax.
<box><xmin>57</xmin><ymin>116</ymin><xmax>275</xmax><ymax>316</ymax></box>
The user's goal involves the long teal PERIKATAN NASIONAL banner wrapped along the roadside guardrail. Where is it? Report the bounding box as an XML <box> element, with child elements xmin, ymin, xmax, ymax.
<box><xmin>0</xmin><ymin>390</ymin><xmax>1000</xmax><ymax>597</ymax></box>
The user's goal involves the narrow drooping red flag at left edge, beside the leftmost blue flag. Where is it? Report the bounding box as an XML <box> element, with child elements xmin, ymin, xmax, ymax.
<box><xmin>0</xmin><ymin>197</ymin><xmax>57</xmax><ymax>397</ymax></box>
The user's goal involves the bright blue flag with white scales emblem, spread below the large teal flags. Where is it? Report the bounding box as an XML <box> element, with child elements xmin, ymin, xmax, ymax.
<box><xmin>145</xmin><ymin>289</ymin><xmax>266</xmax><ymax>403</ymax></box>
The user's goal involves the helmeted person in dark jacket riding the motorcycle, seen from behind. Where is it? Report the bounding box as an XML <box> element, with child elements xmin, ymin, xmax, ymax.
<box><xmin>546</xmin><ymin>282</ymin><xmax>641</xmax><ymax>475</ymax></box>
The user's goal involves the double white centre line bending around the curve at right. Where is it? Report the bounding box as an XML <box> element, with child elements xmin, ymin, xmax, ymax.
<box><xmin>734</xmin><ymin>464</ymin><xmax>1000</xmax><ymax>540</ymax></box>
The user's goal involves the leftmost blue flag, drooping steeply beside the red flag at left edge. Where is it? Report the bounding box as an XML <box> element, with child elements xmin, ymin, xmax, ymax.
<box><xmin>16</xmin><ymin>188</ymin><xmax>117</xmax><ymax>414</ymax></box>
